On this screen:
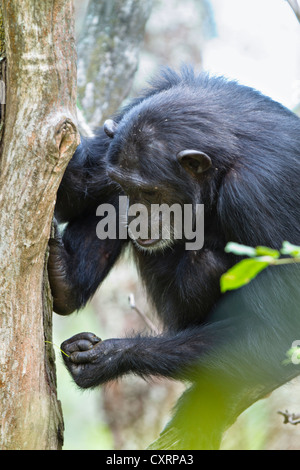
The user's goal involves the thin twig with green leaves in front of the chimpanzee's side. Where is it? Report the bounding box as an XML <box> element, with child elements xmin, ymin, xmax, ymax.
<box><xmin>220</xmin><ymin>242</ymin><xmax>300</xmax><ymax>293</ymax></box>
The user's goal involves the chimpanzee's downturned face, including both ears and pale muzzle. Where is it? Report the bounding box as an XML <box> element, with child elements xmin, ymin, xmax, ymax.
<box><xmin>104</xmin><ymin>117</ymin><xmax>211</xmax><ymax>251</ymax></box>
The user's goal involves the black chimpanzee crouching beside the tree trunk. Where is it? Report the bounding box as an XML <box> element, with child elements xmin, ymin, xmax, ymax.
<box><xmin>49</xmin><ymin>67</ymin><xmax>300</xmax><ymax>449</ymax></box>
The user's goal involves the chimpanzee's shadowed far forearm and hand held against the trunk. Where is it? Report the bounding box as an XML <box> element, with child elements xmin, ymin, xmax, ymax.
<box><xmin>48</xmin><ymin>210</ymin><xmax>126</xmax><ymax>315</ymax></box>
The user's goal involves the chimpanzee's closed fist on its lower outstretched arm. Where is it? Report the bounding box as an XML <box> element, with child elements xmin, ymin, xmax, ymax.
<box><xmin>61</xmin><ymin>333</ymin><xmax>129</xmax><ymax>388</ymax></box>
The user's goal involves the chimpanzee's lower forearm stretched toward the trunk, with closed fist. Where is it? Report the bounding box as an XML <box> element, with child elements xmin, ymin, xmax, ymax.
<box><xmin>61</xmin><ymin>317</ymin><xmax>291</xmax><ymax>388</ymax></box>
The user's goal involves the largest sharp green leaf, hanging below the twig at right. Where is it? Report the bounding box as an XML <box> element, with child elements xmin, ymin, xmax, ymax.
<box><xmin>220</xmin><ymin>259</ymin><xmax>269</xmax><ymax>293</ymax></box>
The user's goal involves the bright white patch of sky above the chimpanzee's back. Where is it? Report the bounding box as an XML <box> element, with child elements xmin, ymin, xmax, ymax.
<box><xmin>204</xmin><ymin>0</ymin><xmax>300</xmax><ymax>108</ymax></box>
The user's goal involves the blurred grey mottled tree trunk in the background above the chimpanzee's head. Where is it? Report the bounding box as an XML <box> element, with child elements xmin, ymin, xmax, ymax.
<box><xmin>78</xmin><ymin>0</ymin><xmax>152</xmax><ymax>128</ymax></box>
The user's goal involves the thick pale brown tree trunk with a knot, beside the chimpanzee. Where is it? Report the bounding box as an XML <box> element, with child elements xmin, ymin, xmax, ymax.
<box><xmin>0</xmin><ymin>0</ymin><xmax>79</xmax><ymax>450</ymax></box>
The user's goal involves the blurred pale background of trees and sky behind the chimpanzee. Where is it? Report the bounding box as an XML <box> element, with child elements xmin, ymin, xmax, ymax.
<box><xmin>54</xmin><ymin>0</ymin><xmax>300</xmax><ymax>450</ymax></box>
